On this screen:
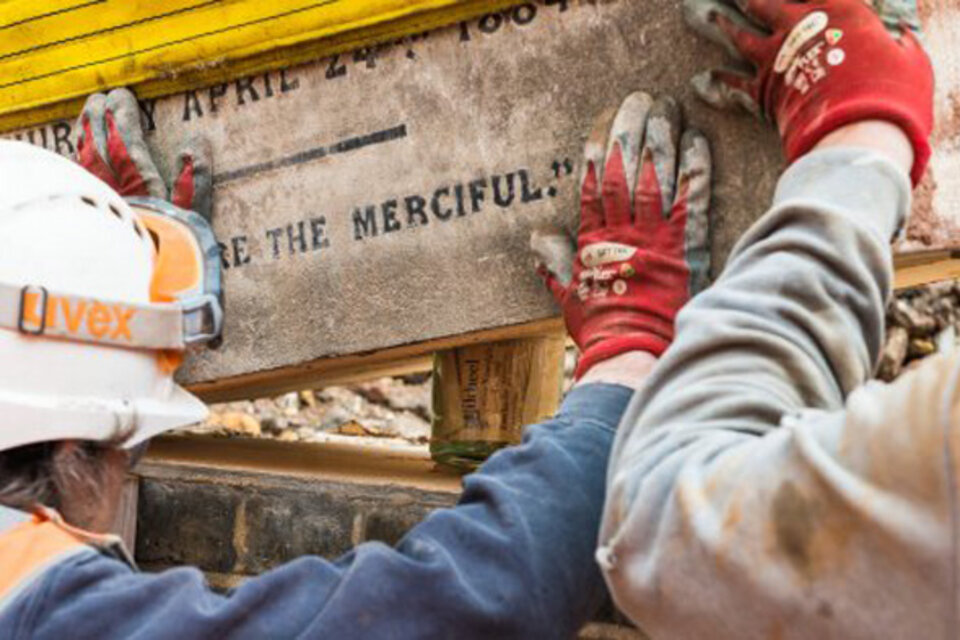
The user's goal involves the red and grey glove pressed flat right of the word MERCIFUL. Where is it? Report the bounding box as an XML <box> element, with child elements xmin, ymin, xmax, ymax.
<box><xmin>533</xmin><ymin>93</ymin><xmax>710</xmax><ymax>378</ymax></box>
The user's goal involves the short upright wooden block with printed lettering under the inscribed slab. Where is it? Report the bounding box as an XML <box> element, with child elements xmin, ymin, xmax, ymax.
<box><xmin>430</xmin><ymin>332</ymin><xmax>566</xmax><ymax>470</ymax></box>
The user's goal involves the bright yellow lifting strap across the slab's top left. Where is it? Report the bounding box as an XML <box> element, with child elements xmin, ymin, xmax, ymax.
<box><xmin>0</xmin><ymin>0</ymin><xmax>518</xmax><ymax>130</ymax></box>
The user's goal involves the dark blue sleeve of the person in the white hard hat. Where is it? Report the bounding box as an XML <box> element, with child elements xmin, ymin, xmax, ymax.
<box><xmin>24</xmin><ymin>385</ymin><xmax>632</xmax><ymax>640</ymax></box>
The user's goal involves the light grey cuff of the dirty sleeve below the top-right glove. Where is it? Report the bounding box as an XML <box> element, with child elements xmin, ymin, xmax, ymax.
<box><xmin>774</xmin><ymin>147</ymin><xmax>911</xmax><ymax>241</ymax></box>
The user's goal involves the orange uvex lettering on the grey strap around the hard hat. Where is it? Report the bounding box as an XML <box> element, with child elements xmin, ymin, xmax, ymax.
<box><xmin>21</xmin><ymin>292</ymin><xmax>137</xmax><ymax>342</ymax></box>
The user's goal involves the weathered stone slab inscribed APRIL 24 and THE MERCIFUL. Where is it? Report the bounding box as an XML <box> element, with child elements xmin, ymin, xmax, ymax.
<box><xmin>11</xmin><ymin>0</ymin><xmax>960</xmax><ymax>399</ymax></box>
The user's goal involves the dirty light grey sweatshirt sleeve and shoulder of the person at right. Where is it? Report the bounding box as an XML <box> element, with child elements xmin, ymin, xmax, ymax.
<box><xmin>597</xmin><ymin>149</ymin><xmax>960</xmax><ymax>640</ymax></box>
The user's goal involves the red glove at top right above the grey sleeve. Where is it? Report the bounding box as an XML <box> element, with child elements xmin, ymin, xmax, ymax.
<box><xmin>685</xmin><ymin>0</ymin><xmax>933</xmax><ymax>184</ymax></box>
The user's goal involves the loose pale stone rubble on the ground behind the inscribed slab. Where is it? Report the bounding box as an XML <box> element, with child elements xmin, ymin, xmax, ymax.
<box><xmin>190</xmin><ymin>281</ymin><xmax>960</xmax><ymax>444</ymax></box>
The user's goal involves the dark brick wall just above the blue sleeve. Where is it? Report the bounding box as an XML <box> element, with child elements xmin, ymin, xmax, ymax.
<box><xmin>136</xmin><ymin>463</ymin><xmax>641</xmax><ymax>640</ymax></box>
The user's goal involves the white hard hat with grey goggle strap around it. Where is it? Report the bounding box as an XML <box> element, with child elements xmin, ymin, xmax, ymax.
<box><xmin>0</xmin><ymin>141</ymin><xmax>220</xmax><ymax>451</ymax></box>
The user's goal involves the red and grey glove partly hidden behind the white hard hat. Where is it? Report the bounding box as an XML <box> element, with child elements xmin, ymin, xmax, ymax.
<box><xmin>76</xmin><ymin>89</ymin><xmax>213</xmax><ymax>220</ymax></box>
